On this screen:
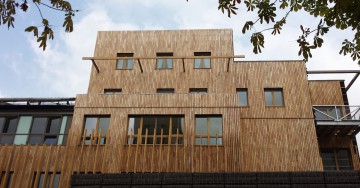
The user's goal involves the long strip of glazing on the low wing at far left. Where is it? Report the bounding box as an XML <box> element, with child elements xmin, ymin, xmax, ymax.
<box><xmin>0</xmin><ymin>116</ymin><xmax>72</xmax><ymax>145</ymax></box>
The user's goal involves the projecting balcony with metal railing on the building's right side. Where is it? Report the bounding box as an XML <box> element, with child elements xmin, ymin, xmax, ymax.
<box><xmin>313</xmin><ymin>105</ymin><xmax>360</xmax><ymax>137</ymax></box>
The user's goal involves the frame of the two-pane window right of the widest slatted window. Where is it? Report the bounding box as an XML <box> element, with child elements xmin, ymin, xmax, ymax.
<box><xmin>194</xmin><ymin>114</ymin><xmax>224</xmax><ymax>146</ymax></box>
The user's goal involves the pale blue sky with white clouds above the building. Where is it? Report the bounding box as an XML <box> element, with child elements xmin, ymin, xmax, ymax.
<box><xmin>0</xmin><ymin>0</ymin><xmax>360</xmax><ymax>144</ymax></box>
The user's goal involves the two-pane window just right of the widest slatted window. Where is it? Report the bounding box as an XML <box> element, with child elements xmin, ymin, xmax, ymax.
<box><xmin>195</xmin><ymin>116</ymin><xmax>222</xmax><ymax>145</ymax></box>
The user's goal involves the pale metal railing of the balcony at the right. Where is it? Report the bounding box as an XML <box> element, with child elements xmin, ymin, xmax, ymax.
<box><xmin>313</xmin><ymin>105</ymin><xmax>360</xmax><ymax>121</ymax></box>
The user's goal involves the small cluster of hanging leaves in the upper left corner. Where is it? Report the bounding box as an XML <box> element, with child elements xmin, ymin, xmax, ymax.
<box><xmin>0</xmin><ymin>0</ymin><xmax>78</xmax><ymax>50</ymax></box>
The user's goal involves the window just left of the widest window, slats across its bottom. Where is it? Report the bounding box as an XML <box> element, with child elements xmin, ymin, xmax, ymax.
<box><xmin>83</xmin><ymin>116</ymin><xmax>110</xmax><ymax>145</ymax></box>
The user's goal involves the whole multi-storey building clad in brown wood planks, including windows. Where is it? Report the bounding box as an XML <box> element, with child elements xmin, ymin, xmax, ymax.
<box><xmin>0</xmin><ymin>29</ymin><xmax>360</xmax><ymax>187</ymax></box>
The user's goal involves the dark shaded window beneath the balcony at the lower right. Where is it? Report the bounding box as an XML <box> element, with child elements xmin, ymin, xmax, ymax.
<box><xmin>321</xmin><ymin>149</ymin><xmax>352</xmax><ymax>170</ymax></box>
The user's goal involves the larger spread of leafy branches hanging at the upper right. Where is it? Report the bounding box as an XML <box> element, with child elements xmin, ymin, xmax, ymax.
<box><xmin>218</xmin><ymin>0</ymin><xmax>360</xmax><ymax>64</ymax></box>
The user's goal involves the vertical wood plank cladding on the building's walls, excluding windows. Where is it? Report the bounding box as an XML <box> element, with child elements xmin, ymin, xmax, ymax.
<box><xmin>0</xmin><ymin>29</ymin><xmax>360</xmax><ymax>187</ymax></box>
